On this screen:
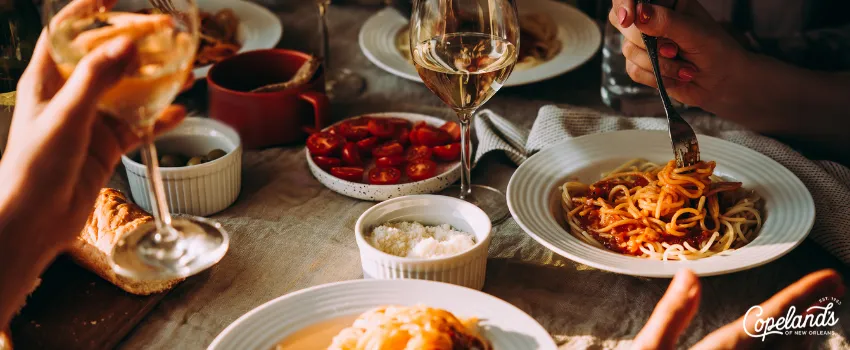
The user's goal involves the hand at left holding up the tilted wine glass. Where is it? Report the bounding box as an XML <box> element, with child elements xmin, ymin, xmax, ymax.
<box><xmin>0</xmin><ymin>30</ymin><xmax>185</xmax><ymax>254</ymax></box>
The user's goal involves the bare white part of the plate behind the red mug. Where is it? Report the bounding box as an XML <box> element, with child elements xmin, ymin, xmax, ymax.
<box><xmin>192</xmin><ymin>0</ymin><xmax>283</xmax><ymax>80</ymax></box>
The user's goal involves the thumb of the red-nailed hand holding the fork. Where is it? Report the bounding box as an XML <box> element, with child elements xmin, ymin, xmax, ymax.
<box><xmin>635</xmin><ymin>3</ymin><xmax>709</xmax><ymax>51</ymax></box>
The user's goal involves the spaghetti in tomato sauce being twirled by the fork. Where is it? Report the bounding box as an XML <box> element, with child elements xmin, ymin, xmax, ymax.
<box><xmin>561</xmin><ymin>159</ymin><xmax>762</xmax><ymax>260</ymax></box>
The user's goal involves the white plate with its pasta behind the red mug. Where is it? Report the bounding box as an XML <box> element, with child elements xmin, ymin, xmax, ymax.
<box><xmin>192</xmin><ymin>0</ymin><xmax>283</xmax><ymax>79</ymax></box>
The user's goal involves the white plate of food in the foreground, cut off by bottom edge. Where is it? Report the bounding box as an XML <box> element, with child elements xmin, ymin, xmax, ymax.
<box><xmin>207</xmin><ymin>280</ymin><xmax>556</xmax><ymax>350</ymax></box>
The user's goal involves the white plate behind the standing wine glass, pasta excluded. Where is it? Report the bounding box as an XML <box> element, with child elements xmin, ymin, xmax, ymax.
<box><xmin>358</xmin><ymin>0</ymin><xmax>602</xmax><ymax>86</ymax></box>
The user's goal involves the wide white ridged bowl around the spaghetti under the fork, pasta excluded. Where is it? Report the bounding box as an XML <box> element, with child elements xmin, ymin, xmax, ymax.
<box><xmin>507</xmin><ymin>130</ymin><xmax>815</xmax><ymax>278</ymax></box>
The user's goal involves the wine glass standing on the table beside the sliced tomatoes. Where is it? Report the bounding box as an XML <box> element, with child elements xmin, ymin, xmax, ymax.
<box><xmin>410</xmin><ymin>0</ymin><xmax>519</xmax><ymax>223</ymax></box>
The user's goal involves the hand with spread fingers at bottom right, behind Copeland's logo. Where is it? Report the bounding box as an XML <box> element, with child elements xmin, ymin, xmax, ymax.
<box><xmin>632</xmin><ymin>270</ymin><xmax>844</xmax><ymax>349</ymax></box>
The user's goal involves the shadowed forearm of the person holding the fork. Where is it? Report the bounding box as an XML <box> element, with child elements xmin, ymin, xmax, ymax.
<box><xmin>708</xmin><ymin>56</ymin><xmax>850</xmax><ymax>160</ymax></box>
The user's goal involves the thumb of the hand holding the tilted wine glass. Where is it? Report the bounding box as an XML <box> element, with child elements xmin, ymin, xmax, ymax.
<box><xmin>45</xmin><ymin>37</ymin><xmax>135</xmax><ymax>124</ymax></box>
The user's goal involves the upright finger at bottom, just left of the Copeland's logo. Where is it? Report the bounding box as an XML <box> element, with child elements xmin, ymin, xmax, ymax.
<box><xmin>632</xmin><ymin>269</ymin><xmax>701</xmax><ymax>349</ymax></box>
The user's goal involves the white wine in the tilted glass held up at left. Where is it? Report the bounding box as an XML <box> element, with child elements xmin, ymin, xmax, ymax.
<box><xmin>50</xmin><ymin>12</ymin><xmax>195</xmax><ymax>128</ymax></box>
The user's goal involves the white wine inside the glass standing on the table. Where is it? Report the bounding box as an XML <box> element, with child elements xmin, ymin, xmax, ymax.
<box><xmin>412</xmin><ymin>33</ymin><xmax>517</xmax><ymax>111</ymax></box>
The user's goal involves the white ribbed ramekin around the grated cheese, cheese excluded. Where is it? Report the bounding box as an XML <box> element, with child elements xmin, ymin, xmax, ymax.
<box><xmin>354</xmin><ymin>195</ymin><xmax>492</xmax><ymax>290</ymax></box>
